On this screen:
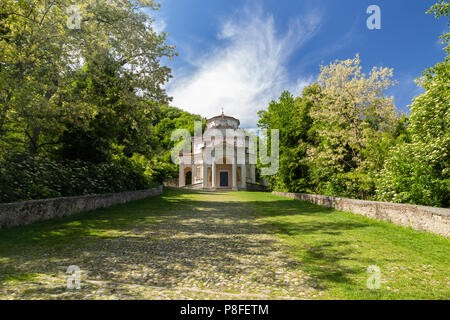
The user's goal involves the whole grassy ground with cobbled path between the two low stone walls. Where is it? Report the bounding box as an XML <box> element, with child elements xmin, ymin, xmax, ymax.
<box><xmin>0</xmin><ymin>188</ymin><xmax>450</xmax><ymax>299</ymax></box>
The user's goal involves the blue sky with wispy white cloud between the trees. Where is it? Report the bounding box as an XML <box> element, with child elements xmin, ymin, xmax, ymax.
<box><xmin>147</xmin><ymin>0</ymin><xmax>448</xmax><ymax>128</ymax></box>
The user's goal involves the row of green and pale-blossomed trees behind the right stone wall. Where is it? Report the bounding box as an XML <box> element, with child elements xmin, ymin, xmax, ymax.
<box><xmin>258</xmin><ymin>50</ymin><xmax>450</xmax><ymax>207</ymax></box>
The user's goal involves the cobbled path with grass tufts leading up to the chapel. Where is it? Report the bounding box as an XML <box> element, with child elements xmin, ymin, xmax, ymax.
<box><xmin>0</xmin><ymin>192</ymin><xmax>319</xmax><ymax>299</ymax></box>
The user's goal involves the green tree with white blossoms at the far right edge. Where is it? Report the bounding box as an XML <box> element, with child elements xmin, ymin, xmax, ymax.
<box><xmin>378</xmin><ymin>1</ymin><xmax>450</xmax><ymax>207</ymax></box>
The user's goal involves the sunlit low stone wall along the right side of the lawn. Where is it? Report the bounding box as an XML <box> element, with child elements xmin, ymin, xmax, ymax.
<box><xmin>272</xmin><ymin>192</ymin><xmax>450</xmax><ymax>237</ymax></box>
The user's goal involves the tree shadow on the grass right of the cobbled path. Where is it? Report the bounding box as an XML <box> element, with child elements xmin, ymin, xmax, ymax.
<box><xmin>243</xmin><ymin>199</ymin><xmax>373</xmax><ymax>290</ymax></box>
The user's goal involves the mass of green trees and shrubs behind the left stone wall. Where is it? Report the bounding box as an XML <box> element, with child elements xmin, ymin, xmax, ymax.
<box><xmin>0</xmin><ymin>0</ymin><xmax>201</xmax><ymax>202</ymax></box>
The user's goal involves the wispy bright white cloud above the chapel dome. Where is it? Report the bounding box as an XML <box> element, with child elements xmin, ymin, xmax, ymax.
<box><xmin>168</xmin><ymin>7</ymin><xmax>321</xmax><ymax>127</ymax></box>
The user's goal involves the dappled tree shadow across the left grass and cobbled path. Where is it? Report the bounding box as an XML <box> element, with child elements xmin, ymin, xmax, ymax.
<box><xmin>0</xmin><ymin>189</ymin><xmax>304</xmax><ymax>295</ymax></box>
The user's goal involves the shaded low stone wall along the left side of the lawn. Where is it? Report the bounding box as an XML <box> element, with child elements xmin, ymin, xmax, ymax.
<box><xmin>0</xmin><ymin>185</ymin><xmax>163</xmax><ymax>228</ymax></box>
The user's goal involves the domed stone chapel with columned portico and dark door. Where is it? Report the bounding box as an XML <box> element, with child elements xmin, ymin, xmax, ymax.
<box><xmin>178</xmin><ymin>113</ymin><xmax>256</xmax><ymax>191</ymax></box>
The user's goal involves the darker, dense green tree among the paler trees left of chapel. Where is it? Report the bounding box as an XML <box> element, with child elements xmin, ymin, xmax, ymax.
<box><xmin>57</xmin><ymin>54</ymin><xmax>156</xmax><ymax>162</ymax></box>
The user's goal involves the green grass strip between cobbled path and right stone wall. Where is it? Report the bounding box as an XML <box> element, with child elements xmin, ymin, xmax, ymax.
<box><xmin>240</xmin><ymin>193</ymin><xmax>450</xmax><ymax>299</ymax></box>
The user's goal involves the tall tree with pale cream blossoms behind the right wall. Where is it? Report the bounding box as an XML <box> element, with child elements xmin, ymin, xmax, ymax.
<box><xmin>309</xmin><ymin>55</ymin><xmax>398</xmax><ymax>198</ymax></box>
